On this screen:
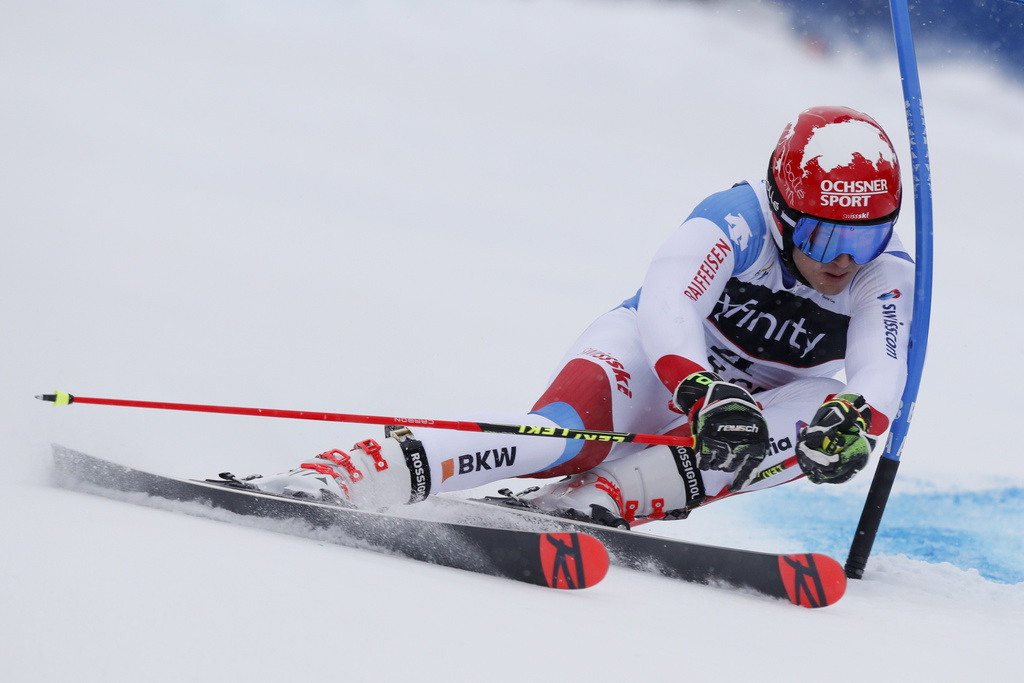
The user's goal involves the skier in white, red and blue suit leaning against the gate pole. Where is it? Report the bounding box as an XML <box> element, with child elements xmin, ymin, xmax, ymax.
<box><xmin>240</xmin><ymin>106</ymin><xmax>913</xmax><ymax>526</ymax></box>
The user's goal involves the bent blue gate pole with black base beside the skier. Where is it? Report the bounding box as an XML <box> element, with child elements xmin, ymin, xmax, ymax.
<box><xmin>845</xmin><ymin>0</ymin><xmax>932</xmax><ymax>579</ymax></box>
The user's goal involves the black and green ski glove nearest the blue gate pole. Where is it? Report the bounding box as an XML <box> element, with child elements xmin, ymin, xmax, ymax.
<box><xmin>797</xmin><ymin>393</ymin><xmax>877</xmax><ymax>483</ymax></box>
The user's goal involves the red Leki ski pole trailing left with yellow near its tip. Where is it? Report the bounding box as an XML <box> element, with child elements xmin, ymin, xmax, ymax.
<box><xmin>36</xmin><ymin>391</ymin><xmax>693</xmax><ymax>446</ymax></box>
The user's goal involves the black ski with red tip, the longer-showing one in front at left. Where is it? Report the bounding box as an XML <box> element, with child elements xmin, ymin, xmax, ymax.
<box><xmin>53</xmin><ymin>445</ymin><xmax>608</xmax><ymax>589</ymax></box>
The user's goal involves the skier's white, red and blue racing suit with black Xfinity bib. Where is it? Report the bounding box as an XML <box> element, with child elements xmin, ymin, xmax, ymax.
<box><xmin>399</xmin><ymin>181</ymin><xmax>913</xmax><ymax>518</ymax></box>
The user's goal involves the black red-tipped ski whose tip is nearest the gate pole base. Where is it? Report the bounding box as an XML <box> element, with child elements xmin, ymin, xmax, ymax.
<box><xmin>436</xmin><ymin>490</ymin><xmax>846</xmax><ymax>607</ymax></box>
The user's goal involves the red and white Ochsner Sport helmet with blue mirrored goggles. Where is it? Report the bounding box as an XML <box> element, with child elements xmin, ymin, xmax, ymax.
<box><xmin>768</xmin><ymin>106</ymin><xmax>903</xmax><ymax>263</ymax></box>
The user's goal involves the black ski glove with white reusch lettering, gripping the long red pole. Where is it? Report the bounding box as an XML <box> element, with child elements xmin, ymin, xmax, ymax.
<box><xmin>673</xmin><ymin>372</ymin><xmax>769</xmax><ymax>493</ymax></box>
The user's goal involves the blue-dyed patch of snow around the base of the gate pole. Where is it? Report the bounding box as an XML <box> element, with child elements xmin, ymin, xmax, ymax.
<box><xmin>737</xmin><ymin>482</ymin><xmax>1024</xmax><ymax>584</ymax></box>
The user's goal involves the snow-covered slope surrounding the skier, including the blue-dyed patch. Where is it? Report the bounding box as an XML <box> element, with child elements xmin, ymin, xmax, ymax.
<box><xmin>0</xmin><ymin>0</ymin><xmax>1024</xmax><ymax>682</ymax></box>
